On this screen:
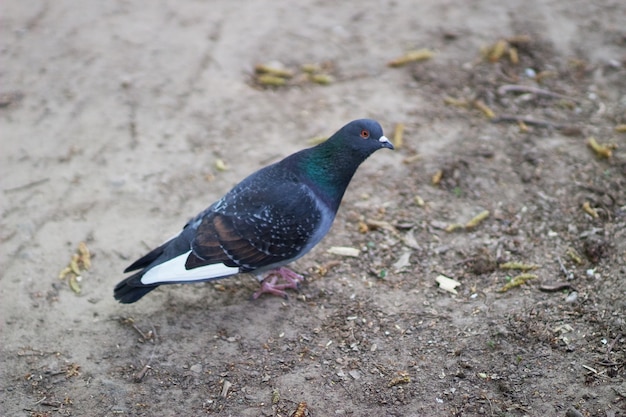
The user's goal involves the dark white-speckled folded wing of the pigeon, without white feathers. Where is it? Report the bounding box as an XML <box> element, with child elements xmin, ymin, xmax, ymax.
<box><xmin>186</xmin><ymin>172</ymin><xmax>322</xmax><ymax>271</ymax></box>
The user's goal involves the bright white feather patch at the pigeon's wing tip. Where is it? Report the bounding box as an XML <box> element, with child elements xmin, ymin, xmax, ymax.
<box><xmin>141</xmin><ymin>251</ymin><xmax>239</xmax><ymax>285</ymax></box>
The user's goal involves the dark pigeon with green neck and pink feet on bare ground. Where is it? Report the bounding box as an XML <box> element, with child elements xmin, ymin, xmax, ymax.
<box><xmin>114</xmin><ymin>119</ymin><xmax>393</xmax><ymax>304</ymax></box>
